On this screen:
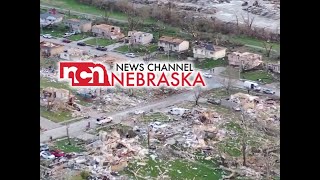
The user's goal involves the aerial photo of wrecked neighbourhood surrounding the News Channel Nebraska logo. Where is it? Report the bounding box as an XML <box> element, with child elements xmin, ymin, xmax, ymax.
<box><xmin>40</xmin><ymin>0</ymin><xmax>280</xmax><ymax>180</ymax></box>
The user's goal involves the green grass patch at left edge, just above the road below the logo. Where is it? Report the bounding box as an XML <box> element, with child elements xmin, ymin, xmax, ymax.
<box><xmin>40</xmin><ymin>106</ymin><xmax>72</xmax><ymax>123</ymax></box>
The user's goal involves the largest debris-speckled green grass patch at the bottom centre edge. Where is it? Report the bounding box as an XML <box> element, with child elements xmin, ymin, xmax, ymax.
<box><xmin>123</xmin><ymin>158</ymin><xmax>222</xmax><ymax>180</ymax></box>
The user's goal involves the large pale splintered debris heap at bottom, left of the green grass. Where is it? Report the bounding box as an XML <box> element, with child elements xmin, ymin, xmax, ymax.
<box><xmin>75</xmin><ymin>130</ymin><xmax>148</xmax><ymax>177</ymax></box>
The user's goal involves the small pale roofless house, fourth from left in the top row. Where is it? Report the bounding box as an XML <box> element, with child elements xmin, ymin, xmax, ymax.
<box><xmin>128</xmin><ymin>31</ymin><xmax>153</xmax><ymax>45</ymax></box>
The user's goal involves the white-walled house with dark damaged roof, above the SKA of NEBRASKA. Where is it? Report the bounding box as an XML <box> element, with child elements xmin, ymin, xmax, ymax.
<box><xmin>193</xmin><ymin>43</ymin><xmax>227</xmax><ymax>60</ymax></box>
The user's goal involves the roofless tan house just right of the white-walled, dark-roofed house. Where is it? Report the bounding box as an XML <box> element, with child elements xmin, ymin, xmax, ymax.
<box><xmin>228</xmin><ymin>52</ymin><xmax>263</xmax><ymax>70</ymax></box>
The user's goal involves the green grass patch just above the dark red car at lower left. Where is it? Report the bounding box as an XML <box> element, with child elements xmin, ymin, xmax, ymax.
<box><xmin>54</xmin><ymin>138</ymin><xmax>84</xmax><ymax>153</ymax></box>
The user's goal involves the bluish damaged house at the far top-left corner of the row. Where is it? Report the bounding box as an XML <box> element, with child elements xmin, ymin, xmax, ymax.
<box><xmin>40</xmin><ymin>9</ymin><xmax>63</xmax><ymax>26</ymax></box>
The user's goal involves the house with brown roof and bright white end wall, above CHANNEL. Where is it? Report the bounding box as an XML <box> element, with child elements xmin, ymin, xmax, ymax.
<box><xmin>158</xmin><ymin>36</ymin><xmax>189</xmax><ymax>52</ymax></box>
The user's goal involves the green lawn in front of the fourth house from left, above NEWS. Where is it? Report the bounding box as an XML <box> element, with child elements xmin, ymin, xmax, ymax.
<box><xmin>115</xmin><ymin>44</ymin><xmax>158</xmax><ymax>56</ymax></box>
